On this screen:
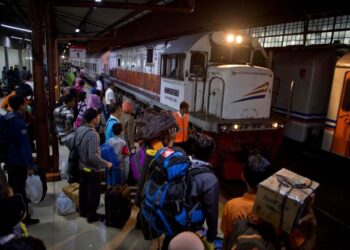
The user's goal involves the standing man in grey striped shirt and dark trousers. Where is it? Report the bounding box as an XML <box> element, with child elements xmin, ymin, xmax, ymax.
<box><xmin>68</xmin><ymin>108</ymin><xmax>112</xmax><ymax>223</ymax></box>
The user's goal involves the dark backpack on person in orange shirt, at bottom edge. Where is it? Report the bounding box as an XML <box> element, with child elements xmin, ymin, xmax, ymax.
<box><xmin>227</xmin><ymin>219</ymin><xmax>279</xmax><ymax>250</ymax></box>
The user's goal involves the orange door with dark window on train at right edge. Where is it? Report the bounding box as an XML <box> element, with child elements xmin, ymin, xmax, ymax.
<box><xmin>332</xmin><ymin>71</ymin><xmax>350</xmax><ymax>157</ymax></box>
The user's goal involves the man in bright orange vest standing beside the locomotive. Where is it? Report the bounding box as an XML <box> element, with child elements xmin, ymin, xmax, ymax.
<box><xmin>173</xmin><ymin>101</ymin><xmax>190</xmax><ymax>152</ymax></box>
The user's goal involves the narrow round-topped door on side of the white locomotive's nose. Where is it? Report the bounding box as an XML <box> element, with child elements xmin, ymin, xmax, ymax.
<box><xmin>207</xmin><ymin>77</ymin><xmax>225</xmax><ymax>118</ymax></box>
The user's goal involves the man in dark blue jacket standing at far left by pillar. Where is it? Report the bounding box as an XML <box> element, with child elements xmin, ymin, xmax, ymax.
<box><xmin>5</xmin><ymin>95</ymin><xmax>39</xmax><ymax>225</ymax></box>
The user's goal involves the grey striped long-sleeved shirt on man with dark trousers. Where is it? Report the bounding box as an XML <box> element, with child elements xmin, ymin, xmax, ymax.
<box><xmin>75</xmin><ymin>126</ymin><xmax>108</xmax><ymax>170</ymax></box>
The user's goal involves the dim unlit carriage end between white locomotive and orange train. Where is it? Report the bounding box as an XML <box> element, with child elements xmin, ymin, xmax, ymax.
<box><xmin>272</xmin><ymin>44</ymin><xmax>349</xmax><ymax>143</ymax></box>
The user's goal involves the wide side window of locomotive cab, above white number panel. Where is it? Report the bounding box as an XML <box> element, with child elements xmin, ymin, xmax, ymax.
<box><xmin>161</xmin><ymin>54</ymin><xmax>186</xmax><ymax>80</ymax></box>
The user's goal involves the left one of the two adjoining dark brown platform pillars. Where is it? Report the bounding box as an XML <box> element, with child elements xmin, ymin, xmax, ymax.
<box><xmin>28</xmin><ymin>0</ymin><xmax>51</xmax><ymax>170</ymax></box>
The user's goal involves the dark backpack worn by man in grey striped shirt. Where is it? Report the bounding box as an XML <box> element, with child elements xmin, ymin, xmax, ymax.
<box><xmin>68</xmin><ymin>129</ymin><xmax>90</xmax><ymax>184</ymax></box>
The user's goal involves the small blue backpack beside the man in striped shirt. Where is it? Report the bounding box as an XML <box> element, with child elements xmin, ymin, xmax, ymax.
<box><xmin>101</xmin><ymin>142</ymin><xmax>121</xmax><ymax>186</ymax></box>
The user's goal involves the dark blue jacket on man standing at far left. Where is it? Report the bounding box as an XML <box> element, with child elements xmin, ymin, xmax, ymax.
<box><xmin>6</xmin><ymin>111</ymin><xmax>34</xmax><ymax>167</ymax></box>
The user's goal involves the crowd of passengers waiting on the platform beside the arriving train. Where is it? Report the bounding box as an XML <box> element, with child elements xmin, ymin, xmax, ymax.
<box><xmin>0</xmin><ymin>67</ymin><xmax>316</xmax><ymax>249</ymax></box>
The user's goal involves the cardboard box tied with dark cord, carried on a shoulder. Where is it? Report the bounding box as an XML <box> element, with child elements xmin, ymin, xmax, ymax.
<box><xmin>253</xmin><ymin>168</ymin><xmax>319</xmax><ymax>233</ymax></box>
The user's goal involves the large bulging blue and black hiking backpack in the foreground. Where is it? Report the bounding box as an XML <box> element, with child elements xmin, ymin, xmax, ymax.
<box><xmin>141</xmin><ymin>147</ymin><xmax>208</xmax><ymax>236</ymax></box>
